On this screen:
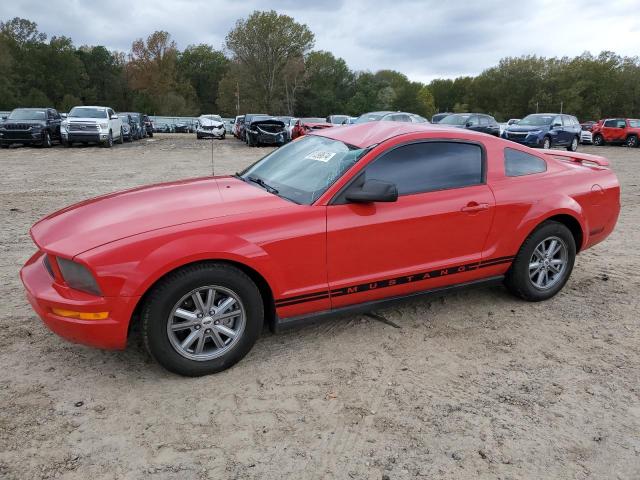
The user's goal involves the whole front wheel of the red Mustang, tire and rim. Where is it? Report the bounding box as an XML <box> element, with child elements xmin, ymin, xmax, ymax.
<box><xmin>142</xmin><ymin>263</ymin><xmax>264</xmax><ymax>377</ymax></box>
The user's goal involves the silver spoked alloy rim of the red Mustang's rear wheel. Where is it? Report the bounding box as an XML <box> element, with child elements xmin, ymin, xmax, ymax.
<box><xmin>529</xmin><ymin>236</ymin><xmax>569</xmax><ymax>290</ymax></box>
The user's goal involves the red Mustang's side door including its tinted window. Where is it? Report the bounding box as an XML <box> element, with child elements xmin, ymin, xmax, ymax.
<box><xmin>327</xmin><ymin>141</ymin><xmax>495</xmax><ymax>309</ymax></box>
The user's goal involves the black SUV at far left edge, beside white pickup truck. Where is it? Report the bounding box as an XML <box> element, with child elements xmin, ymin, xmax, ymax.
<box><xmin>0</xmin><ymin>108</ymin><xmax>62</xmax><ymax>148</ymax></box>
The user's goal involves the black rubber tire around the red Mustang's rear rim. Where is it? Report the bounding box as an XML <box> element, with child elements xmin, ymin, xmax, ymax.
<box><xmin>505</xmin><ymin>221</ymin><xmax>576</xmax><ymax>302</ymax></box>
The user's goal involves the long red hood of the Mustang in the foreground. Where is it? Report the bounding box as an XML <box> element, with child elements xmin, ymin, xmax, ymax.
<box><xmin>31</xmin><ymin>177</ymin><xmax>291</xmax><ymax>257</ymax></box>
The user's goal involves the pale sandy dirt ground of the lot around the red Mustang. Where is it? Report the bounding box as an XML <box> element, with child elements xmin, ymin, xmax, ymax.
<box><xmin>0</xmin><ymin>135</ymin><xmax>640</xmax><ymax>480</ymax></box>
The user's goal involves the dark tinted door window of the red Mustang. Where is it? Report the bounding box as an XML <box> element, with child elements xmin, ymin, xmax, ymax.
<box><xmin>365</xmin><ymin>142</ymin><xmax>483</xmax><ymax>195</ymax></box>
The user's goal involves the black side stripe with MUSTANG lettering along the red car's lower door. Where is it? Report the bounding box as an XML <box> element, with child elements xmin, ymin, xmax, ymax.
<box><xmin>275</xmin><ymin>256</ymin><xmax>515</xmax><ymax>307</ymax></box>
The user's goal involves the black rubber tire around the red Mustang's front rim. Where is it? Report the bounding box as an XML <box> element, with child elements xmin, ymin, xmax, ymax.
<box><xmin>141</xmin><ymin>262</ymin><xmax>264</xmax><ymax>377</ymax></box>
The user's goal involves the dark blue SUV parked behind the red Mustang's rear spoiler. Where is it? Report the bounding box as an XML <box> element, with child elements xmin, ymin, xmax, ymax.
<box><xmin>502</xmin><ymin>113</ymin><xmax>582</xmax><ymax>152</ymax></box>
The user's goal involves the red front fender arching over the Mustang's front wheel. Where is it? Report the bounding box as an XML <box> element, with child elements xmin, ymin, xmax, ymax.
<box><xmin>78</xmin><ymin>231</ymin><xmax>282</xmax><ymax>297</ymax></box>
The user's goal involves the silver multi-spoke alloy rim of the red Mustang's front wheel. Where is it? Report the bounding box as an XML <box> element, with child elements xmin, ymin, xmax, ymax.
<box><xmin>167</xmin><ymin>285</ymin><xmax>246</xmax><ymax>362</ymax></box>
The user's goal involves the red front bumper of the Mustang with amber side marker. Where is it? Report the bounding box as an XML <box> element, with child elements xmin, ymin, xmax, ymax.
<box><xmin>20</xmin><ymin>252</ymin><xmax>140</xmax><ymax>350</ymax></box>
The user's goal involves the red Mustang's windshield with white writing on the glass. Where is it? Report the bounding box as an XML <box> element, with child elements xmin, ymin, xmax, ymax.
<box><xmin>241</xmin><ymin>135</ymin><xmax>367</xmax><ymax>205</ymax></box>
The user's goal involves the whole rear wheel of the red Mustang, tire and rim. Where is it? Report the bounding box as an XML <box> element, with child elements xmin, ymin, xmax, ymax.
<box><xmin>505</xmin><ymin>221</ymin><xmax>576</xmax><ymax>302</ymax></box>
